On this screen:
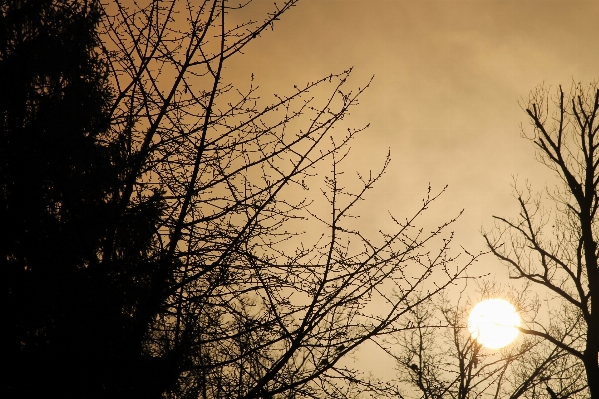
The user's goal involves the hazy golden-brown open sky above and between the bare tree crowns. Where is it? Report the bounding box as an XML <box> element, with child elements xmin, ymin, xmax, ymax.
<box><xmin>225</xmin><ymin>0</ymin><xmax>599</xmax><ymax>380</ymax></box>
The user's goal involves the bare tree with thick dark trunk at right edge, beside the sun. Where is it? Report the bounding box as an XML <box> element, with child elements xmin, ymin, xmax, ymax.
<box><xmin>483</xmin><ymin>82</ymin><xmax>599</xmax><ymax>398</ymax></box>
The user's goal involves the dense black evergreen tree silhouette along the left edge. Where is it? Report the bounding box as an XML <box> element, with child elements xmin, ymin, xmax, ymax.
<box><xmin>0</xmin><ymin>0</ymin><xmax>118</xmax><ymax>397</ymax></box>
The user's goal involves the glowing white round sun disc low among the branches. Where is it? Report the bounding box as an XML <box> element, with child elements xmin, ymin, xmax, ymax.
<box><xmin>468</xmin><ymin>299</ymin><xmax>520</xmax><ymax>349</ymax></box>
